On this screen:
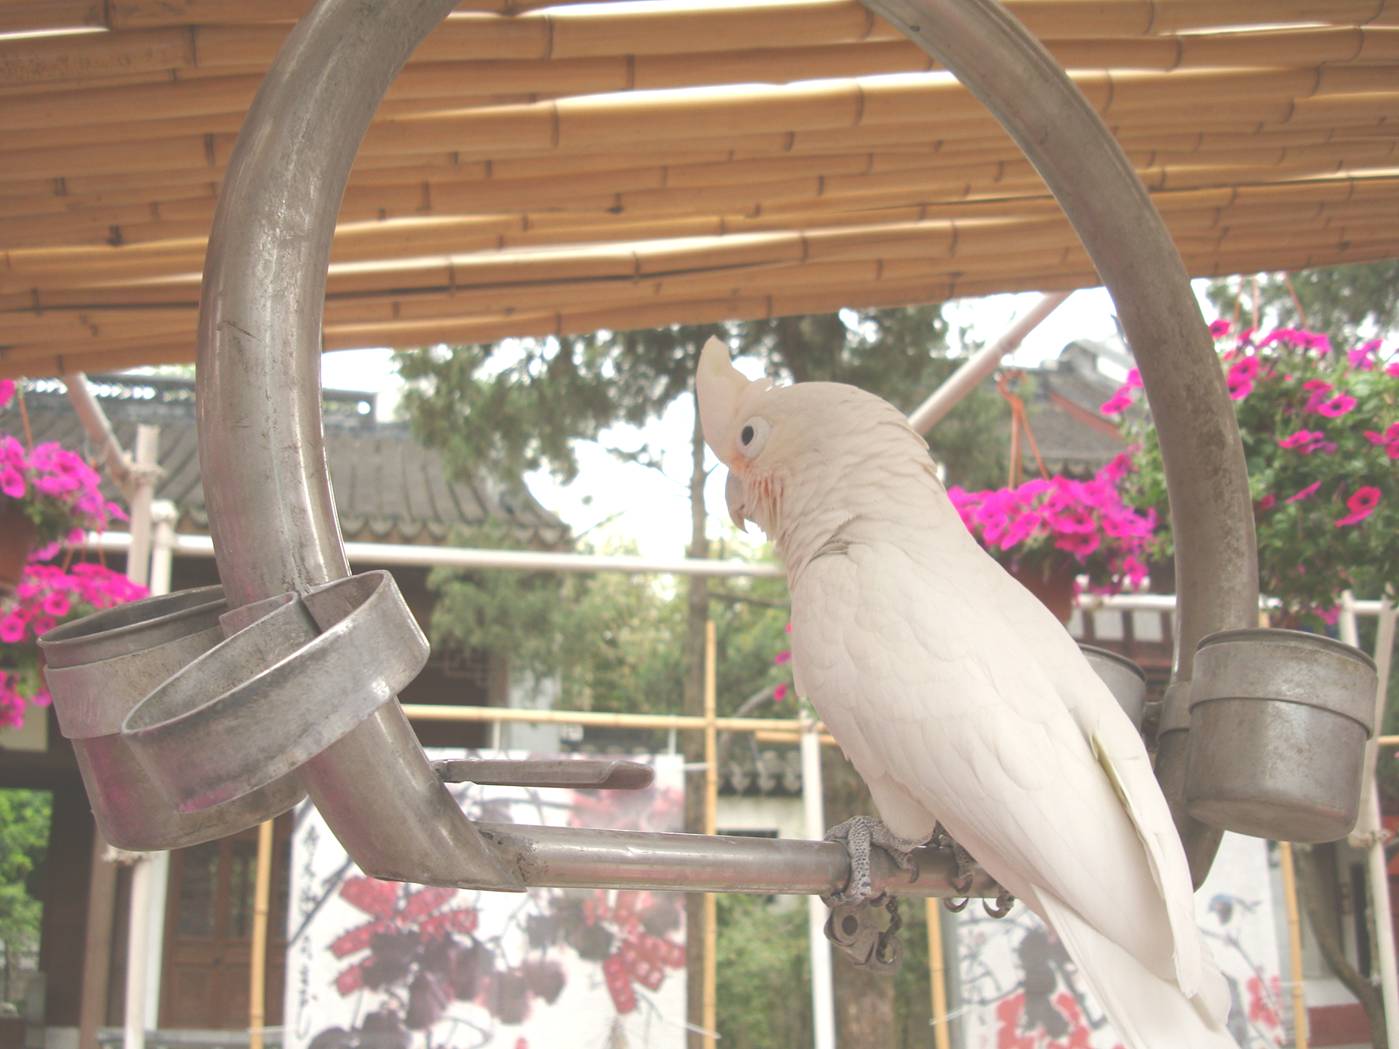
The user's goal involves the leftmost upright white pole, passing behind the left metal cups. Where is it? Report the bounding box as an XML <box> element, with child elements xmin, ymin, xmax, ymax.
<box><xmin>122</xmin><ymin>425</ymin><xmax>160</xmax><ymax>1049</ymax></box>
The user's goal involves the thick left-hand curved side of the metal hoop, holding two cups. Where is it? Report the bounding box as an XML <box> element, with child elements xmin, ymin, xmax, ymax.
<box><xmin>196</xmin><ymin>0</ymin><xmax>512</xmax><ymax>888</ymax></box>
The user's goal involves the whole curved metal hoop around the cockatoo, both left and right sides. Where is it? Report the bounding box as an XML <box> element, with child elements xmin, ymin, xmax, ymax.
<box><xmin>197</xmin><ymin>0</ymin><xmax>1258</xmax><ymax>891</ymax></box>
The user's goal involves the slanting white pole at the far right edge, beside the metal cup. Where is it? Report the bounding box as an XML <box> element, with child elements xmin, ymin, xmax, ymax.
<box><xmin>1340</xmin><ymin>590</ymin><xmax>1399</xmax><ymax>1046</ymax></box>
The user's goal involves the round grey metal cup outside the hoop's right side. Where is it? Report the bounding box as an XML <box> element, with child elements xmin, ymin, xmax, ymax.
<box><xmin>1185</xmin><ymin>629</ymin><xmax>1378</xmax><ymax>842</ymax></box>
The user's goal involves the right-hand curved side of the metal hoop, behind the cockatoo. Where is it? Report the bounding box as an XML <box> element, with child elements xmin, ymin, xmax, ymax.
<box><xmin>863</xmin><ymin>0</ymin><xmax>1258</xmax><ymax>885</ymax></box>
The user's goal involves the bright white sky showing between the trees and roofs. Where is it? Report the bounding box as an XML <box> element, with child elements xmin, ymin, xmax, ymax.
<box><xmin>322</xmin><ymin>281</ymin><xmax>1203</xmax><ymax>557</ymax></box>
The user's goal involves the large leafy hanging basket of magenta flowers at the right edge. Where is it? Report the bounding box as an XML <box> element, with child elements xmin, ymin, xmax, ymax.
<box><xmin>1101</xmin><ymin>320</ymin><xmax>1399</xmax><ymax>629</ymax></box>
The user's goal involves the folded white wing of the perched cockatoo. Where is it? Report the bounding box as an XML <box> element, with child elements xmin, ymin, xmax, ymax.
<box><xmin>793</xmin><ymin>536</ymin><xmax>1219</xmax><ymax>1012</ymax></box>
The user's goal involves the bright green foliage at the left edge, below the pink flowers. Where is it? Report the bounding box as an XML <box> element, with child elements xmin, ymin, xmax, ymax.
<box><xmin>0</xmin><ymin>790</ymin><xmax>53</xmax><ymax>993</ymax></box>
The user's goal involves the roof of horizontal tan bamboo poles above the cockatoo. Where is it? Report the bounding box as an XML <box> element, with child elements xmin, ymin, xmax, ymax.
<box><xmin>0</xmin><ymin>0</ymin><xmax>1399</xmax><ymax>376</ymax></box>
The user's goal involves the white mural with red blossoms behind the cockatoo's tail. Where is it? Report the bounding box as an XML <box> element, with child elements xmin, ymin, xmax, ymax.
<box><xmin>953</xmin><ymin>834</ymin><xmax>1290</xmax><ymax>1049</ymax></box>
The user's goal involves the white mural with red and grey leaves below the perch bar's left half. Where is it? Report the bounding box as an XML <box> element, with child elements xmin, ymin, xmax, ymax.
<box><xmin>284</xmin><ymin>751</ymin><xmax>686</xmax><ymax>1049</ymax></box>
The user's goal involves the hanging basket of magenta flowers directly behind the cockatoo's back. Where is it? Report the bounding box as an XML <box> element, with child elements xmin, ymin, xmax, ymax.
<box><xmin>947</xmin><ymin>455</ymin><xmax>1156</xmax><ymax>622</ymax></box>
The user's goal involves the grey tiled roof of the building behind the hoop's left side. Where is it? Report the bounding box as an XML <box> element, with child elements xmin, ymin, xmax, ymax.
<box><xmin>9</xmin><ymin>376</ymin><xmax>568</xmax><ymax>547</ymax></box>
